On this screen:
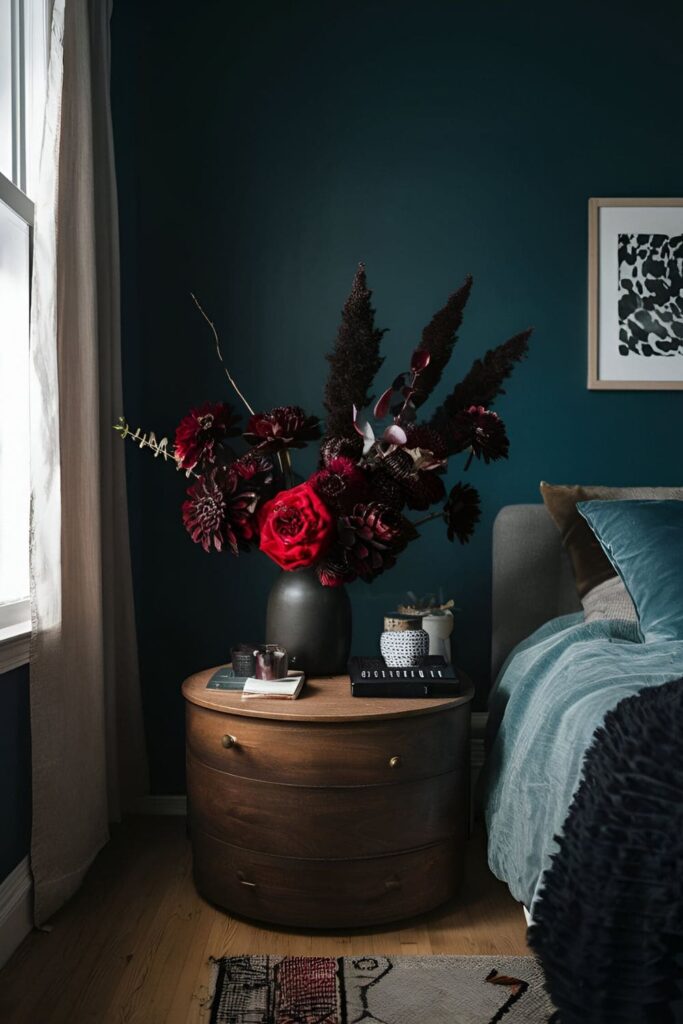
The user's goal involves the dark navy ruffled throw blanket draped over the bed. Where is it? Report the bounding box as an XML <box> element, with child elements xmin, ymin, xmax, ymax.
<box><xmin>529</xmin><ymin>680</ymin><xmax>683</xmax><ymax>1024</ymax></box>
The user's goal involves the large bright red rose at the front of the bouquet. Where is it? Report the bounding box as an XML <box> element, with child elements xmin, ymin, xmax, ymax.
<box><xmin>258</xmin><ymin>483</ymin><xmax>335</xmax><ymax>571</ymax></box>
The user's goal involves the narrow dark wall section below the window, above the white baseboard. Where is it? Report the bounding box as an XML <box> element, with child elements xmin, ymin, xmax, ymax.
<box><xmin>0</xmin><ymin>665</ymin><xmax>31</xmax><ymax>882</ymax></box>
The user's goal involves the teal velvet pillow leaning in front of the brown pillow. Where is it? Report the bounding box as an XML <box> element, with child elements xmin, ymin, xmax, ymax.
<box><xmin>577</xmin><ymin>501</ymin><xmax>683</xmax><ymax>642</ymax></box>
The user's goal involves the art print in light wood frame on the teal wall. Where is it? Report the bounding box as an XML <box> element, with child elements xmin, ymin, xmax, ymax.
<box><xmin>588</xmin><ymin>199</ymin><xmax>683</xmax><ymax>390</ymax></box>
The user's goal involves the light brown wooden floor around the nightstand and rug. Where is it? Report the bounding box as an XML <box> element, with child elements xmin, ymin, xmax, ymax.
<box><xmin>0</xmin><ymin>817</ymin><xmax>528</xmax><ymax>1024</ymax></box>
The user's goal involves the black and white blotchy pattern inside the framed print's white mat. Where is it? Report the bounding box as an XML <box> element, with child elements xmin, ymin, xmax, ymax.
<box><xmin>617</xmin><ymin>234</ymin><xmax>683</xmax><ymax>358</ymax></box>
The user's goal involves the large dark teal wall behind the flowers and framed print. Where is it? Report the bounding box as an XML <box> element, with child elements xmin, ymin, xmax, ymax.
<box><xmin>114</xmin><ymin>0</ymin><xmax>683</xmax><ymax>792</ymax></box>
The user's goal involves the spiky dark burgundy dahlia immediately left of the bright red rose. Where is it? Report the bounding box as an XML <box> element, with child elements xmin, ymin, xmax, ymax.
<box><xmin>182</xmin><ymin>466</ymin><xmax>258</xmax><ymax>555</ymax></box>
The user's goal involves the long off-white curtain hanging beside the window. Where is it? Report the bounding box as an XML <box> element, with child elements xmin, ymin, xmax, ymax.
<box><xmin>31</xmin><ymin>0</ymin><xmax>146</xmax><ymax>924</ymax></box>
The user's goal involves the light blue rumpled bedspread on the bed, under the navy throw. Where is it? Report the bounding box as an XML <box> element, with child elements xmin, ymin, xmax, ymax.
<box><xmin>485</xmin><ymin>613</ymin><xmax>683</xmax><ymax>912</ymax></box>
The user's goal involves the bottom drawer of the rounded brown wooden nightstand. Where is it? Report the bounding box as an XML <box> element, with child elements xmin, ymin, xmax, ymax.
<box><xmin>193</xmin><ymin>830</ymin><xmax>464</xmax><ymax>928</ymax></box>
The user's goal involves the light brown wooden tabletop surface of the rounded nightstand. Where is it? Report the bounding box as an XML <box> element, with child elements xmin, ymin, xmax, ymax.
<box><xmin>182</xmin><ymin>669</ymin><xmax>474</xmax><ymax>722</ymax></box>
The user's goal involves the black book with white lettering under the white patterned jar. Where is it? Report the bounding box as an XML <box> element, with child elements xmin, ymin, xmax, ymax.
<box><xmin>348</xmin><ymin>655</ymin><xmax>462</xmax><ymax>697</ymax></box>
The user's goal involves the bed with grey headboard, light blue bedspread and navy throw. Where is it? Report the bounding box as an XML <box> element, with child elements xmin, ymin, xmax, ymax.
<box><xmin>484</xmin><ymin>505</ymin><xmax>683</xmax><ymax>1024</ymax></box>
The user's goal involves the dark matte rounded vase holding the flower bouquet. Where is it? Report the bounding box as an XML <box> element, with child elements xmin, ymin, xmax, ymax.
<box><xmin>265</xmin><ymin>569</ymin><xmax>351</xmax><ymax>676</ymax></box>
